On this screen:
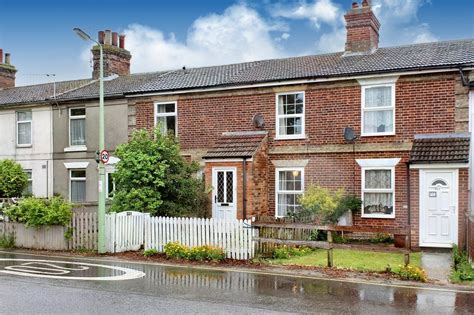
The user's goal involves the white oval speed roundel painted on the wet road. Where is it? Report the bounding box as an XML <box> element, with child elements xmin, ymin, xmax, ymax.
<box><xmin>0</xmin><ymin>258</ymin><xmax>145</xmax><ymax>281</ymax></box>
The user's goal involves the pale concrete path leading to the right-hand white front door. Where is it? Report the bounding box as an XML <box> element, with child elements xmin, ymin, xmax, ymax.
<box><xmin>421</xmin><ymin>251</ymin><xmax>452</xmax><ymax>283</ymax></box>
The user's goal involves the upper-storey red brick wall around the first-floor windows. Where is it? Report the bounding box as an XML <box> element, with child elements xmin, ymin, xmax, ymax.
<box><xmin>136</xmin><ymin>75</ymin><xmax>455</xmax><ymax>149</ymax></box>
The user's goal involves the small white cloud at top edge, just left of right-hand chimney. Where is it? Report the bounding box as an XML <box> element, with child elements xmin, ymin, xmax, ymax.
<box><xmin>270</xmin><ymin>0</ymin><xmax>341</xmax><ymax>28</ymax></box>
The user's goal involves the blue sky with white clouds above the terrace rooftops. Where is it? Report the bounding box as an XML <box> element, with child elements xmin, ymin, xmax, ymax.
<box><xmin>0</xmin><ymin>0</ymin><xmax>474</xmax><ymax>86</ymax></box>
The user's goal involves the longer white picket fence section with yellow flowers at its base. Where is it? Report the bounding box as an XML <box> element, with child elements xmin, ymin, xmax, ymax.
<box><xmin>145</xmin><ymin>217</ymin><xmax>255</xmax><ymax>259</ymax></box>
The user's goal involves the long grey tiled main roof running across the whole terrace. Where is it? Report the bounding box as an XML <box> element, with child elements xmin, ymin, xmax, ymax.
<box><xmin>0</xmin><ymin>39</ymin><xmax>474</xmax><ymax>105</ymax></box>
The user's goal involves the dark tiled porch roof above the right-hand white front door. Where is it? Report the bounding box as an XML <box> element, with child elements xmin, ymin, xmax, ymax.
<box><xmin>410</xmin><ymin>134</ymin><xmax>470</xmax><ymax>163</ymax></box>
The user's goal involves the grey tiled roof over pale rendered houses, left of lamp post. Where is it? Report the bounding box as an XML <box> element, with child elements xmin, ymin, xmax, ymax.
<box><xmin>0</xmin><ymin>79</ymin><xmax>92</xmax><ymax>106</ymax></box>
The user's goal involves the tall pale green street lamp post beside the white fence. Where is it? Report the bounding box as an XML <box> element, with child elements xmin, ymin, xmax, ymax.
<box><xmin>74</xmin><ymin>27</ymin><xmax>105</xmax><ymax>254</ymax></box>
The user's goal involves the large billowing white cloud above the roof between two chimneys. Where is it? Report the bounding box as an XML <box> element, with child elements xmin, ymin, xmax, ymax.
<box><xmin>118</xmin><ymin>4</ymin><xmax>289</xmax><ymax>72</ymax></box>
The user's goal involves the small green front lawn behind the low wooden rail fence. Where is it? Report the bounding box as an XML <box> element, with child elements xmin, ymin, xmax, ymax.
<box><xmin>270</xmin><ymin>249</ymin><xmax>421</xmax><ymax>272</ymax></box>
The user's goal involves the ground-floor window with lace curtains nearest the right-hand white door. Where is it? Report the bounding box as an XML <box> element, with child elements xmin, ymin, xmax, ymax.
<box><xmin>362</xmin><ymin>167</ymin><xmax>395</xmax><ymax>218</ymax></box>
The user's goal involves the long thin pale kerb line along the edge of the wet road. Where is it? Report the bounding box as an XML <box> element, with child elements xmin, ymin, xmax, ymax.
<box><xmin>0</xmin><ymin>250</ymin><xmax>474</xmax><ymax>294</ymax></box>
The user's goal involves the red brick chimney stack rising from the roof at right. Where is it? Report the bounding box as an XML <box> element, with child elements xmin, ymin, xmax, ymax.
<box><xmin>344</xmin><ymin>0</ymin><xmax>380</xmax><ymax>54</ymax></box>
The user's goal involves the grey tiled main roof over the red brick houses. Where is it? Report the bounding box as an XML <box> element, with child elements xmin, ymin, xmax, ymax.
<box><xmin>131</xmin><ymin>39</ymin><xmax>474</xmax><ymax>93</ymax></box>
